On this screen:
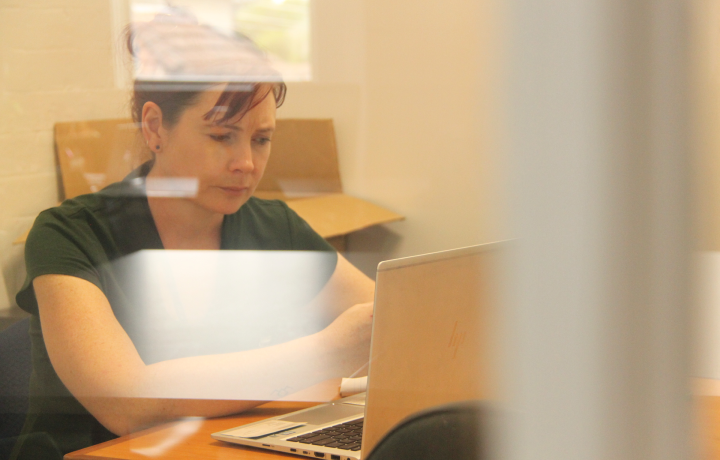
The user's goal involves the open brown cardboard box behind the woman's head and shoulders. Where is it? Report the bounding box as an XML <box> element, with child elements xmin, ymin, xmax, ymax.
<box><xmin>16</xmin><ymin>119</ymin><xmax>404</xmax><ymax>251</ymax></box>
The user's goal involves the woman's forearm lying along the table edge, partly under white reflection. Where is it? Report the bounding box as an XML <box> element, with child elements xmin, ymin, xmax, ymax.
<box><xmin>79</xmin><ymin>333</ymin><xmax>349</xmax><ymax>435</ymax></box>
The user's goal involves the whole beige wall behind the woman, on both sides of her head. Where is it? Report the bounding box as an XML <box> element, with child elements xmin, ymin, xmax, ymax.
<box><xmin>0</xmin><ymin>0</ymin><xmax>503</xmax><ymax>307</ymax></box>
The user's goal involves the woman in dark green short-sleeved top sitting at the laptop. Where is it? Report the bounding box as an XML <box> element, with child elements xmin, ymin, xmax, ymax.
<box><xmin>16</xmin><ymin>16</ymin><xmax>374</xmax><ymax>458</ymax></box>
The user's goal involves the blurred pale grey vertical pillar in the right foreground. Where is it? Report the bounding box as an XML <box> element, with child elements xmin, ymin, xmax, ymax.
<box><xmin>507</xmin><ymin>0</ymin><xmax>696</xmax><ymax>460</ymax></box>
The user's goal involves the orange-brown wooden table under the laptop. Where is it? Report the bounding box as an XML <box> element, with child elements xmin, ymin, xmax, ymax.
<box><xmin>65</xmin><ymin>379</ymin><xmax>720</xmax><ymax>460</ymax></box>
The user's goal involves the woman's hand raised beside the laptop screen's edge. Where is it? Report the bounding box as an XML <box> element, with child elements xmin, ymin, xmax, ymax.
<box><xmin>319</xmin><ymin>302</ymin><xmax>373</xmax><ymax>377</ymax></box>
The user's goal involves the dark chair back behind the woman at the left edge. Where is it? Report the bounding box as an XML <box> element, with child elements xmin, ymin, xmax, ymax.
<box><xmin>0</xmin><ymin>318</ymin><xmax>32</xmax><ymax>459</ymax></box>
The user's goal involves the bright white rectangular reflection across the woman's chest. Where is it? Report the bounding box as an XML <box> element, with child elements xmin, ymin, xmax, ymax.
<box><xmin>109</xmin><ymin>250</ymin><xmax>336</xmax><ymax>399</ymax></box>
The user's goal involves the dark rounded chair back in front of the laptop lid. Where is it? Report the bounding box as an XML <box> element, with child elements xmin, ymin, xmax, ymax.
<box><xmin>367</xmin><ymin>401</ymin><xmax>496</xmax><ymax>460</ymax></box>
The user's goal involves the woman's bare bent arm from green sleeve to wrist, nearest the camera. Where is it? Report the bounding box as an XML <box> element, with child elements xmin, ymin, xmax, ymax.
<box><xmin>33</xmin><ymin>272</ymin><xmax>372</xmax><ymax>435</ymax></box>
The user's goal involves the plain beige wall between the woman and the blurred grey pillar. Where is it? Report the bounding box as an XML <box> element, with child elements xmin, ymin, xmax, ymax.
<box><xmin>280</xmin><ymin>0</ymin><xmax>507</xmax><ymax>273</ymax></box>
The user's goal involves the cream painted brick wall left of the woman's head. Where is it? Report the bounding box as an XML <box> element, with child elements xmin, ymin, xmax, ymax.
<box><xmin>0</xmin><ymin>0</ymin><xmax>126</xmax><ymax>304</ymax></box>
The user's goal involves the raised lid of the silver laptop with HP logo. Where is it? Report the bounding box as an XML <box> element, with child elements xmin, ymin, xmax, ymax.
<box><xmin>362</xmin><ymin>243</ymin><xmax>505</xmax><ymax>457</ymax></box>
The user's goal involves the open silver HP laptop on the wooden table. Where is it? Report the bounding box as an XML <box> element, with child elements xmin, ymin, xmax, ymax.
<box><xmin>212</xmin><ymin>243</ymin><xmax>504</xmax><ymax>460</ymax></box>
